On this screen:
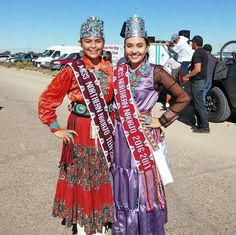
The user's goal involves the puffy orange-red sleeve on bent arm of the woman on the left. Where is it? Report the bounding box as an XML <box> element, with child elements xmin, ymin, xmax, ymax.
<box><xmin>38</xmin><ymin>67</ymin><xmax>73</xmax><ymax>132</ymax></box>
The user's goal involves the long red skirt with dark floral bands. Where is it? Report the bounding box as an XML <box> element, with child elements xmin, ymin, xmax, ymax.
<box><xmin>52</xmin><ymin>114</ymin><xmax>113</xmax><ymax>234</ymax></box>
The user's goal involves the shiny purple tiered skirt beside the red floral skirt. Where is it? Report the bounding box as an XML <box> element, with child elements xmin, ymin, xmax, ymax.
<box><xmin>112</xmin><ymin>122</ymin><xmax>167</xmax><ymax>235</ymax></box>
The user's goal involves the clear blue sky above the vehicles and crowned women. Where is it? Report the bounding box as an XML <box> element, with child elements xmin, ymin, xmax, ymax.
<box><xmin>0</xmin><ymin>0</ymin><xmax>236</xmax><ymax>52</ymax></box>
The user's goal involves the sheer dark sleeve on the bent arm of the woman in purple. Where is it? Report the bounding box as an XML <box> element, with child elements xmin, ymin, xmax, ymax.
<box><xmin>154</xmin><ymin>65</ymin><xmax>191</xmax><ymax>127</ymax></box>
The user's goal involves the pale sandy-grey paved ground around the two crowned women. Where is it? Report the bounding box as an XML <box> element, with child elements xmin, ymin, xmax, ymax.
<box><xmin>0</xmin><ymin>67</ymin><xmax>236</xmax><ymax>235</ymax></box>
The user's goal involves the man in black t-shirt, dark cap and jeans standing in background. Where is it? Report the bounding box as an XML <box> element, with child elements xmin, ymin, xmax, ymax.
<box><xmin>182</xmin><ymin>35</ymin><xmax>210</xmax><ymax>133</ymax></box>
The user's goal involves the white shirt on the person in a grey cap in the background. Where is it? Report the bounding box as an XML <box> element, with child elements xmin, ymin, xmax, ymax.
<box><xmin>172</xmin><ymin>36</ymin><xmax>194</xmax><ymax>62</ymax></box>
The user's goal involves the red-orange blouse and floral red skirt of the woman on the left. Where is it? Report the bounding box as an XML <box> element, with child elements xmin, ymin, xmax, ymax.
<box><xmin>38</xmin><ymin>56</ymin><xmax>113</xmax><ymax>234</ymax></box>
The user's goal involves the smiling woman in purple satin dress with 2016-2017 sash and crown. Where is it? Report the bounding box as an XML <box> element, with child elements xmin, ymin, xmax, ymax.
<box><xmin>112</xmin><ymin>16</ymin><xmax>190</xmax><ymax>235</ymax></box>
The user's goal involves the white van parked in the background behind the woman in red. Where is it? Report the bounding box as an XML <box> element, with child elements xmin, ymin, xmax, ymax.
<box><xmin>34</xmin><ymin>45</ymin><xmax>81</xmax><ymax>67</ymax></box>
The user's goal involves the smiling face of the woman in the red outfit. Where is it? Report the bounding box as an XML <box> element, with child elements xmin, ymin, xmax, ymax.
<box><xmin>80</xmin><ymin>38</ymin><xmax>104</xmax><ymax>59</ymax></box>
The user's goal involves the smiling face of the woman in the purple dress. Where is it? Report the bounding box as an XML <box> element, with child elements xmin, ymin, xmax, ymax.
<box><xmin>125</xmin><ymin>37</ymin><xmax>149</xmax><ymax>69</ymax></box>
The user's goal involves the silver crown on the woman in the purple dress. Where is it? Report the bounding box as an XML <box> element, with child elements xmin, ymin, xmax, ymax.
<box><xmin>125</xmin><ymin>15</ymin><xmax>147</xmax><ymax>38</ymax></box>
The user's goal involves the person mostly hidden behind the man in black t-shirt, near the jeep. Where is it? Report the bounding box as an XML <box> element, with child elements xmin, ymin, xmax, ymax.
<box><xmin>203</xmin><ymin>44</ymin><xmax>217</xmax><ymax>97</ymax></box>
